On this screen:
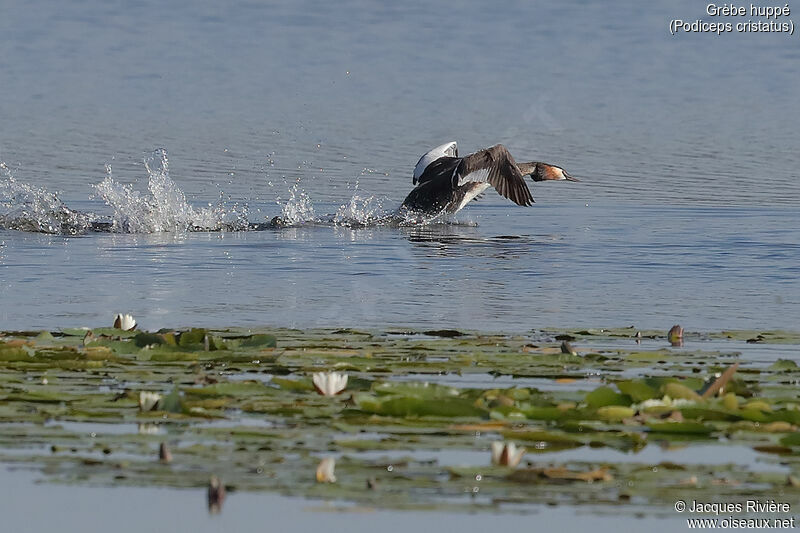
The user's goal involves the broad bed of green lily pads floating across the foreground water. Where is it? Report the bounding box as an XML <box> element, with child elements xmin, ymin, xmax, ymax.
<box><xmin>0</xmin><ymin>324</ymin><xmax>800</xmax><ymax>513</ymax></box>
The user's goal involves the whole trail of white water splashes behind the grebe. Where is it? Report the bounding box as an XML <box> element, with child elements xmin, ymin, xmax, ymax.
<box><xmin>0</xmin><ymin>149</ymin><xmax>460</xmax><ymax>235</ymax></box>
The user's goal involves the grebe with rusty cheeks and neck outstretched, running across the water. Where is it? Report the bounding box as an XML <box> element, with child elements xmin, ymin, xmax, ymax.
<box><xmin>400</xmin><ymin>141</ymin><xmax>580</xmax><ymax>217</ymax></box>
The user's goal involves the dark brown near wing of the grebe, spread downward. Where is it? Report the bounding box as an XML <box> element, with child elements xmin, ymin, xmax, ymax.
<box><xmin>453</xmin><ymin>144</ymin><xmax>533</xmax><ymax>206</ymax></box>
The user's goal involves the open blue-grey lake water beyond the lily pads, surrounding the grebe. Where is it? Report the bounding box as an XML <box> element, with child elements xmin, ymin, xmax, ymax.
<box><xmin>0</xmin><ymin>0</ymin><xmax>800</xmax><ymax>528</ymax></box>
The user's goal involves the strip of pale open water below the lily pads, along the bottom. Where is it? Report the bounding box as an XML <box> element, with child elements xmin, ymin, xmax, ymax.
<box><xmin>3</xmin><ymin>470</ymin><xmax>685</xmax><ymax>533</ymax></box>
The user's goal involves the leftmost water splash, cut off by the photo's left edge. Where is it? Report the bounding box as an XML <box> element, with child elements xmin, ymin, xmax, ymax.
<box><xmin>0</xmin><ymin>158</ymin><xmax>94</xmax><ymax>235</ymax></box>
